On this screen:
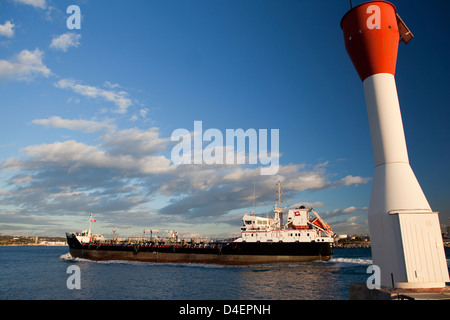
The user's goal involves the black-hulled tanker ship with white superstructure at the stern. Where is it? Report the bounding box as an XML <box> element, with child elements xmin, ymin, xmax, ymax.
<box><xmin>66</xmin><ymin>183</ymin><xmax>335</xmax><ymax>265</ymax></box>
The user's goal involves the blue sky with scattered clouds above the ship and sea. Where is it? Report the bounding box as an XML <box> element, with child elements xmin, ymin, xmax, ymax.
<box><xmin>0</xmin><ymin>0</ymin><xmax>450</xmax><ymax>237</ymax></box>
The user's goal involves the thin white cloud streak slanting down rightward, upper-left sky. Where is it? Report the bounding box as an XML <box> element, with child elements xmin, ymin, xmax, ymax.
<box><xmin>55</xmin><ymin>79</ymin><xmax>133</xmax><ymax>114</ymax></box>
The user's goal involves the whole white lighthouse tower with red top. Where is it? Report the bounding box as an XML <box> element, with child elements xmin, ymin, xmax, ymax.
<box><xmin>341</xmin><ymin>1</ymin><xmax>449</xmax><ymax>289</ymax></box>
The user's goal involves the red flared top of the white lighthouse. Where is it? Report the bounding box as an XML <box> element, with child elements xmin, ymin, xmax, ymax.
<box><xmin>341</xmin><ymin>1</ymin><xmax>400</xmax><ymax>81</ymax></box>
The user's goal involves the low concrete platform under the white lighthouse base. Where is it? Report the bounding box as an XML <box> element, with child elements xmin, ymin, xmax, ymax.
<box><xmin>349</xmin><ymin>283</ymin><xmax>450</xmax><ymax>300</ymax></box>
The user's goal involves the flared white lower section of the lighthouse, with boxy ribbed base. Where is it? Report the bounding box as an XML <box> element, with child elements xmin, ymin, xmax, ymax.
<box><xmin>368</xmin><ymin>163</ymin><xmax>450</xmax><ymax>289</ymax></box>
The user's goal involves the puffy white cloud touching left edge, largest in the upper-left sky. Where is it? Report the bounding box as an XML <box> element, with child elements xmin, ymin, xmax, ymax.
<box><xmin>0</xmin><ymin>49</ymin><xmax>51</xmax><ymax>81</ymax></box>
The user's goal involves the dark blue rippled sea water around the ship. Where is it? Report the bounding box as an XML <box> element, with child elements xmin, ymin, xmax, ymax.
<box><xmin>0</xmin><ymin>247</ymin><xmax>450</xmax><ymax>300</ymax></box>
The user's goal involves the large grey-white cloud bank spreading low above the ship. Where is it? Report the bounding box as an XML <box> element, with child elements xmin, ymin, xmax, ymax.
<box><xmin>0</xmin><ymin>116</ymin><xmax>370</xmax><ymax>235</ymax></box>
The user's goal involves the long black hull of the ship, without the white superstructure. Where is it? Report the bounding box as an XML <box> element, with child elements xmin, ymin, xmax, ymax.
<box><xmin>66</xmin><ymin>233</ymin><xmax>333</xmax><ymax>265</ymax></box>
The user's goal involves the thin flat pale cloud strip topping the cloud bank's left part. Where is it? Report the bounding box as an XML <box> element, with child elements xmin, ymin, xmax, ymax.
<box><xmin>32</xmin><ymin>116</ymin><xmax>115</xmax><ymax>133</ymax></box>
